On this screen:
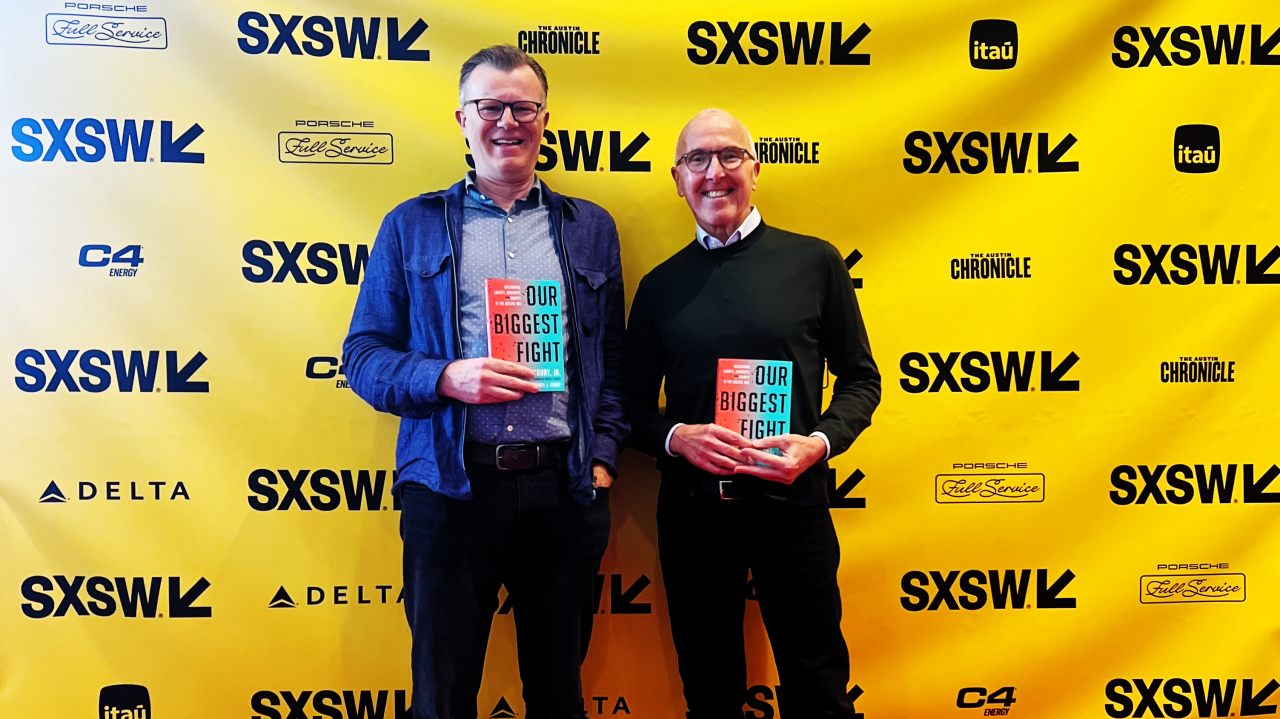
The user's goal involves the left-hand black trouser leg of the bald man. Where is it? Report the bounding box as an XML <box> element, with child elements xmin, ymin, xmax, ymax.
<box><xmin>658</xmin><ymin>486</ymin><xmax>746</xmax><ymax>719</ymax></box>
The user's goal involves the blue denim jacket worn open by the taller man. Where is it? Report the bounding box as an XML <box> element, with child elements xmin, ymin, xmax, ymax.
<box><xmin>342</xmin><ymin>182</ymin><xmax>627</xmax><ymax>504</ymax></box>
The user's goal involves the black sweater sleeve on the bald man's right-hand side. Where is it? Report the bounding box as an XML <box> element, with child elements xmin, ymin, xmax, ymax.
<box><xmin>814</xmin><ymin>244</ymin><xmax>881</xmax><ymax>457</ymax></box>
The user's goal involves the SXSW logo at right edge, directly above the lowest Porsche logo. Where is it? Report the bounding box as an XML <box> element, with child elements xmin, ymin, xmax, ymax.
<box><xmin>1110</xmin><ymin>464</ymin><xmax>1280</xmax><ymax>507</ymax></box>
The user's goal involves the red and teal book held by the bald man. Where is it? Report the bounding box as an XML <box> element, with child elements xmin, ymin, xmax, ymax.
<box><xmin>716</xmin><ymin>360</ymin><xmax>791</xmax><ymax>454</ymax></box>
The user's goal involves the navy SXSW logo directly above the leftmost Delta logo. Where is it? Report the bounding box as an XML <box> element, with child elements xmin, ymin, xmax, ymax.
<box><xmin>14</xmin><ymin>349</ymin><xmax>209</xmax><ymax>393</ymax></box>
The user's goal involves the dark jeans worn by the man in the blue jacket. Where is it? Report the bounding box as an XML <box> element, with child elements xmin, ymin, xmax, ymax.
<box><xmin>401</xmin><ymin>466</ymin><xmax>609</xmax><ymax>719</ymax></box>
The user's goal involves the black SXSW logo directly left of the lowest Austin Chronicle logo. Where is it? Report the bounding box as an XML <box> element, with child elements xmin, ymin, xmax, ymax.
<box><xmin>899</xmin><ymin>351</ymin><xmax>1080</xmax><ymax>394</ymax></box>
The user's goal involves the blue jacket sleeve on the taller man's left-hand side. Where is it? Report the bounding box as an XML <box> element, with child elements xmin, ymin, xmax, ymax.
<box><xmin>342</xmin><ymin>211</ymin><xmax>452</xmax><ymax>418</ymax></box>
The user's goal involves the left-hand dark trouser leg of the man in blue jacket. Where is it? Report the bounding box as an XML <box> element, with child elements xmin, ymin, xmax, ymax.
<box><xmin>401</xmin><ymin>478</ymin><xmax>516</xmax><ymax>719</ymax></box>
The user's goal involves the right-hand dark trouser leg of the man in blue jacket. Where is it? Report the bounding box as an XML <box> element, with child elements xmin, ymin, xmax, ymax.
<box><xmin>506</xmin><ymin>470</ymin><xmax>609</xmax><ymax>719</ymax></box>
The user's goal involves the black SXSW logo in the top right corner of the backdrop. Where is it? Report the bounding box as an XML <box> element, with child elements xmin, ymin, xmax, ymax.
<box><xmin>1111</xmin><ymin>24</ymin><xmax>1280</xmax><ymax>69</ymax></box>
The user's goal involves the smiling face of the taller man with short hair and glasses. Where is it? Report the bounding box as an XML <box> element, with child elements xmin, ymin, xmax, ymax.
<box><xmin>456</xmin><ymin>65</ymin><xmax>549</xmax><ymax>182</ymax></box>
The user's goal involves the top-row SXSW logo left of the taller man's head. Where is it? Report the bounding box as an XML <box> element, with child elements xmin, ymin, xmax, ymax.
<box><xmin>236</xmin><ymin>12</ymin><xmax>431</xmax><ymax>63</ymax></box>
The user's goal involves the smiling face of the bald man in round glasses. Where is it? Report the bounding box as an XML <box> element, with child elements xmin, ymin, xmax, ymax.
<box><xmin>671</xmin><ymin>110</ymin><xmax>760</xmax><ymax>239</ymax></box>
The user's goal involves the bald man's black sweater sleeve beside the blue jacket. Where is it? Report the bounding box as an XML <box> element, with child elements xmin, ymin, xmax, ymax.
<box><xmin>626</xmin><ymin>273</ymin><xmax>676</xmax><ymax>457</ymax></box>
